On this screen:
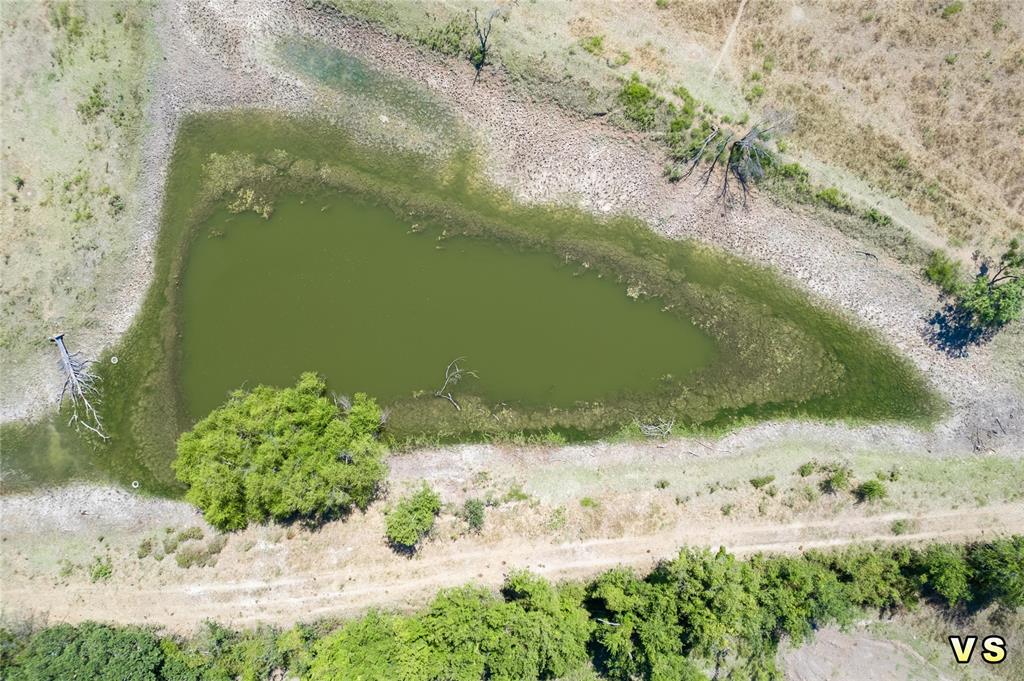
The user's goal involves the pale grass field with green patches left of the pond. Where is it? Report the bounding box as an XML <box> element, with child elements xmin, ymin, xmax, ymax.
<box><xmin>0</xmin><ymin>0</ymin><xmax>156</xmax><ymax>420</ymax></box>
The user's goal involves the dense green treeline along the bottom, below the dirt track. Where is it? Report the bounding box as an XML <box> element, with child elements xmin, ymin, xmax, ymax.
<box><xmin>0</xmin><ymin>537</ymin><xmax>1024</xmax><ymax>681</ymax></box>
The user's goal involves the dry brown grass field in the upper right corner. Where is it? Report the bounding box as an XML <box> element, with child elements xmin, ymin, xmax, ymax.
<box><xmin>732</xmin><ymin>0</ymin><xmax>1024</xmax><ymax>249</ymax></box>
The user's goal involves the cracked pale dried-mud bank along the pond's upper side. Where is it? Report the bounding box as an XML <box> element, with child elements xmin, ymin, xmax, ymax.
<box><xmin>4</xmin><ymin>0</ymin><xmax>1024</xmax><ymax>453</ymax></box>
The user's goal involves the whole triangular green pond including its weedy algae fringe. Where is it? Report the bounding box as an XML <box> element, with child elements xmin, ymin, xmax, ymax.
<box><xmin>0</xmin><ymin>49</ymin><xmax>941</xmax><ymax>495</ymax></box>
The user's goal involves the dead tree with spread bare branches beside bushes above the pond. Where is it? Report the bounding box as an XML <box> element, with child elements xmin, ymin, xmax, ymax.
<box><xmin>680</xmin><ymin>119</ymin><xmax>785</xmax><ymax>206</ymax></box>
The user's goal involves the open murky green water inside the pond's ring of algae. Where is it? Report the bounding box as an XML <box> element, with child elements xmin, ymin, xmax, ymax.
<box><xmin>180</xmin><ymin>194</ymin><xmax>714</xmax><ymax>417</ymax></box>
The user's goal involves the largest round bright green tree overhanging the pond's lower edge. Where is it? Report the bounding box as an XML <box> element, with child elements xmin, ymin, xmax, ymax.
<box><xmin>174</xmin><ymin>374</ymin><xmax>386</xmax><ymax>529</ymax></box>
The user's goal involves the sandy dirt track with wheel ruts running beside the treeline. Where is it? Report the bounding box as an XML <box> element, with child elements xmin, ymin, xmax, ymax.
<box><xmin>2</xmin><ymin>504</ymin><xmax>1024</xmax><ymax>632</ymax></box>
